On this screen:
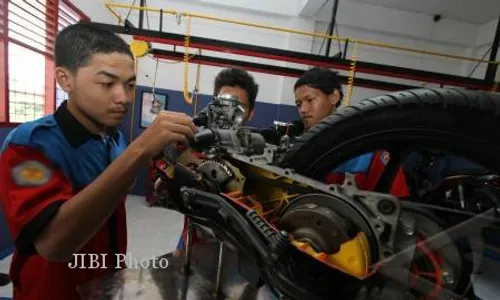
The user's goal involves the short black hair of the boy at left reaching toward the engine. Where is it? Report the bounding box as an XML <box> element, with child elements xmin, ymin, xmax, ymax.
<box><xmin>54</xmin><ymin>23</ymin><xmax>134</xmax><ymax>72</ymax></box>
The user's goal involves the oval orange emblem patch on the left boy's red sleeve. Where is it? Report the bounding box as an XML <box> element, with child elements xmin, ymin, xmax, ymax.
<box><xmin>12</xmin><ymin>160</ymin><xmax>52</xmax><ymax>186</ymax></box>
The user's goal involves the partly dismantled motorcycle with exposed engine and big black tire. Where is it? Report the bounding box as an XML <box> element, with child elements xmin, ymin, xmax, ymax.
<box><xmin>151</xmin><ymin>89</ymin><xmax>500</xmax><ymax>300</ymax></box>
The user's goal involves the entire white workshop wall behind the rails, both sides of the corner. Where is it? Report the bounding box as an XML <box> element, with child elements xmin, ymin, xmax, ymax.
<box><xmin>73</xmin><ymin>0</ymin><xmax>496</xmax><ymax>110</ymax></box>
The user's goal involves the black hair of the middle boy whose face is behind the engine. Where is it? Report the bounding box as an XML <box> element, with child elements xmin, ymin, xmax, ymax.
<box><xmin>214</xmin><ymin>68</ymin><xmax>259</xmax><ymax>111</ymax></box>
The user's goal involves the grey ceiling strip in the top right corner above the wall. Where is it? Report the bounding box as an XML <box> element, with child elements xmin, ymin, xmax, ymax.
<box><xmin>352</xmin><ymin>0</ymin><xmax>500</xmax><ymax>25</ymax></box>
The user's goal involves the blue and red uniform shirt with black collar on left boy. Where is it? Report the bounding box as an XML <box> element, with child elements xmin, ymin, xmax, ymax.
<box><xmin>0</xmin><ymin>102</ymin><xmax>127</xmax><ymax>300</ymax></box>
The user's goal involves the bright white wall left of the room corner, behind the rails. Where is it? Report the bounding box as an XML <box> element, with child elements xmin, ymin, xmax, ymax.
<box><xmin>127</xmin><ymin>0</ymin><xmax>315</xmax><ymax>109</ymax></box>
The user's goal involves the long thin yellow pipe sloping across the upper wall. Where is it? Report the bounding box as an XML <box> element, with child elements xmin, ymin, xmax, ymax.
<box><xmin>105</xmin><ymin>2</ymin><xmax>497</xmax><ymax>64</ymax></box>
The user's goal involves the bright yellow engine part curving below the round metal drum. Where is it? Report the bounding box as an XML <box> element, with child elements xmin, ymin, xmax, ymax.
<box><xmin>292</xmin><ymin>232</ymin><xmax>371</xmax><ymax>279</ymax></box>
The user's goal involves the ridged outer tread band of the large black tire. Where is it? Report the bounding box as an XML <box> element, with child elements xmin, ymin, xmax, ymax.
<box><xmin>280</xmin><ymin>88</ymin><xmax>500</xmax><ymax>176</ymax></box>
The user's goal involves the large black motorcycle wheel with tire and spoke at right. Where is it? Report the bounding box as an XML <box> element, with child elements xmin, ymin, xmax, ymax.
<box><xmin>280</xmin><ymin>89</ymin><xmax>500</xmax><ymax>294</ymax></box>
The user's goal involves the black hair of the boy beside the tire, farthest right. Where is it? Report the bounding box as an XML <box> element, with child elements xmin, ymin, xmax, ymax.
<box><xmin>294</xmin><ymin>67</ymin><xmax>344</xmax><ymax>107</ymax></box>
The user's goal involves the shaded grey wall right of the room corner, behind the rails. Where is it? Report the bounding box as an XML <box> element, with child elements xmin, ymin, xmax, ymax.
<box><xmin>312</xmin><ymin>1</ymin><xmax>497</xmax><ymax>96</ymax></box>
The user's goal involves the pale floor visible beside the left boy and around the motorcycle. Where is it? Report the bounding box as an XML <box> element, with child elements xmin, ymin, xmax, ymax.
<box><xmin>0</xmin><ymin>196</ymin><xmax>500</xmax><ymax>300</ymax></box>
